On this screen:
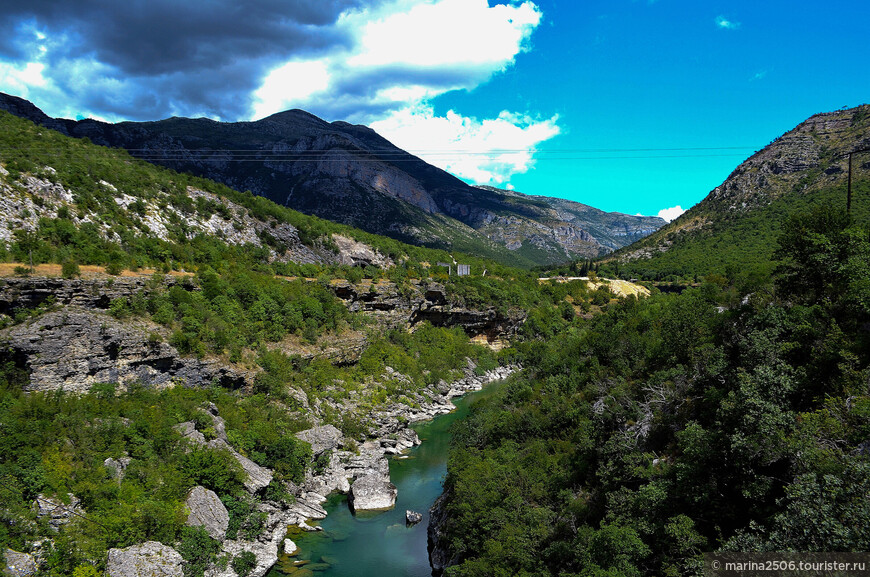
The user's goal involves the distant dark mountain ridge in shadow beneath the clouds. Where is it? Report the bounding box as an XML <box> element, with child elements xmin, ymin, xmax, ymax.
<box><xmin>0</xmin><ymin>94</ymin><xmax>664</xmax><ymax>266</ymax></box>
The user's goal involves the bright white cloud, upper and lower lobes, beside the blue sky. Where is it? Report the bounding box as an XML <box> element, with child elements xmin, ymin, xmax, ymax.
<box><xmin>252</xmin><ymin>0</ymin><xmax>559</xmax><ymax>185</ymax></box>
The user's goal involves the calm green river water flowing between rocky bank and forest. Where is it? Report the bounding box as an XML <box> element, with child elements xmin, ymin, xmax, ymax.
<box><xmin>267</xmin><ymin>382</ymin><xmax>501</xmax><ymax>577</ymax></box>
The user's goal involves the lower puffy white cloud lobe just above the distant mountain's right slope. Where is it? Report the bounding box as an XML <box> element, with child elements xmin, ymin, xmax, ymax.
<box><xmin>371</xmin><ymin>104</ymin><xmax>559</xmax><ymax>185</ymax></box>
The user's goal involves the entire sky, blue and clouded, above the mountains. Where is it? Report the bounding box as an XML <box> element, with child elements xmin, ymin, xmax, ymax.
<box><xmin>0</xmin><ymin>0</ymin><xmax>870</xmax><ymax>218</ymax></box>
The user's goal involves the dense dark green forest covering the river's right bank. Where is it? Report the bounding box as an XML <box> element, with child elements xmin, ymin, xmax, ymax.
<box><xmin>445</xmin><ymin>207</ymin><xmax>870</xmax><ymax>577</ymax></box>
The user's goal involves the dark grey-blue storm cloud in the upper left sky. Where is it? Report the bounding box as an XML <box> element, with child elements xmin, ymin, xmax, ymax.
<box><xmin>0</xmin><ymin>0</ymin><xmax>375</xmax><ymax>119</ymax></box>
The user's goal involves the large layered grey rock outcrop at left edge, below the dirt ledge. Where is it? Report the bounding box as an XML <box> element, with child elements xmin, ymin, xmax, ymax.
<box><xmin>0</xmin><ymin>309</ymin><xmax>250</xmax><ymax>393</ymax></box>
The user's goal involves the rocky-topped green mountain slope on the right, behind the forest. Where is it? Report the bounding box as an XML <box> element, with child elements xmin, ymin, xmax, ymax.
<box><xmin>606</xmin><ymin>105</ymin><xmax>870</xmax><ymax>279</ymax></box>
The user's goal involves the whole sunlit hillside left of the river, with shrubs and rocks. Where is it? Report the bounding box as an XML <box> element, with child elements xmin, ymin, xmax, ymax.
<box><xmin>0</xmin><ymin>104</ymin><xmax>640</xmax><ymax>577</ymax></box>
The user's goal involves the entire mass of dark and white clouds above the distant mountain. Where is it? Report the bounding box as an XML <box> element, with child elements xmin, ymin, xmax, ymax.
<box><xmin>0</xmin><ymin>0</ymin><xmax>559</xmax><ymax>185</ymax></box>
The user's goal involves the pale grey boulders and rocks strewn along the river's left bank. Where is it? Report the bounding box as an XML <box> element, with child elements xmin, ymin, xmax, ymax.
<box><xmin>6</xmin><ymin>363</ymin><xmax>518</xmax><ymax>577</ymax></box>
